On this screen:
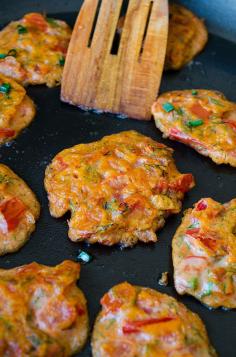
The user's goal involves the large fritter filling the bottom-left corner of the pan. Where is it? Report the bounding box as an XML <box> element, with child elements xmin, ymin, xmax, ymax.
<box><xmin>0</xmin><ymin>261</ymin><xmax>88</xmax><ymax>357</ymax></box>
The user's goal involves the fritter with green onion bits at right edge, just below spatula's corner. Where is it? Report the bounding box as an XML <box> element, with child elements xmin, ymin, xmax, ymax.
<box><xmin>152</xmin><ymin>89</ymin><xmax>236</xmax><ymax>167</ymax></box>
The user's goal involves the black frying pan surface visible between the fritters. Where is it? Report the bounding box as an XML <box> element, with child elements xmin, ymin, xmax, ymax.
<box><xmin>0</xmin><ymin>0</ymin><xmax>236</xmax><ymax>357</ymax></box>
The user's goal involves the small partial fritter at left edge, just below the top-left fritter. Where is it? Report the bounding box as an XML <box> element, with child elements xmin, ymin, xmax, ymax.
<box><xmin>0</xmin><ymin>74</ymin><xmax>35</xmax><ymax>145</ymax></box>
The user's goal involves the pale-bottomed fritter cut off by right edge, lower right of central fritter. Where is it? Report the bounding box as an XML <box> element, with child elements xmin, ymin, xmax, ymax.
<box><xmin>173</xmin><ymin>198</ymin><xmax>236</xmax><ymax>308</ymax></box>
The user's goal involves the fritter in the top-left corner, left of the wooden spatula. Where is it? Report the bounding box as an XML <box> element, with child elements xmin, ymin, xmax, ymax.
<box><xmin>0</xmin><ymin>13</ymin><xmax>71</xmax><ymax>87</ymax></box>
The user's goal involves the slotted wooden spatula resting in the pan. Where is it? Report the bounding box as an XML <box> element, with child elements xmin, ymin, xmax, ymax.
<box><xmin>61</xmin><ymin>0</ymin><xmax>168</xmax><ymax>120</ymax></box>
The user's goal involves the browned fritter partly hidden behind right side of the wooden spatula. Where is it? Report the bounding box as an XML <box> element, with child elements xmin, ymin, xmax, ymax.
<box><xmin>165</xmin><ymin>4</ymin><xmax>208</xmax><ymax>70</ymax></box>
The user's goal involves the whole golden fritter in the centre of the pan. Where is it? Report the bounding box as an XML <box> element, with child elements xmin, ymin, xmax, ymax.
<box><xmin>45</xmin><ymin>131</ymin><xmax>194</xmax><ymax>246</ymax></box>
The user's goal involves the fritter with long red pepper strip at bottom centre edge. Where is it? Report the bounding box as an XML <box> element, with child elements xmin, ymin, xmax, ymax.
<box><xmin>92</xmin><ymin>283</ymin><xmax>216</xmax><ymax>357</ymax></box>
